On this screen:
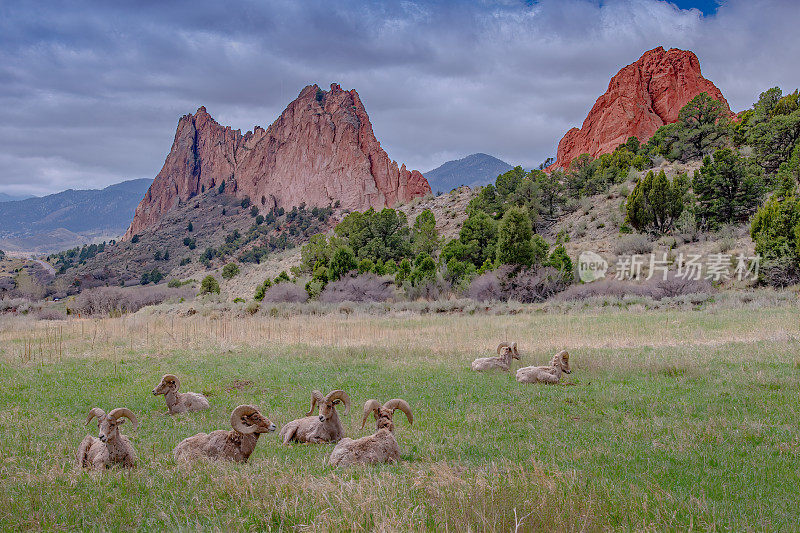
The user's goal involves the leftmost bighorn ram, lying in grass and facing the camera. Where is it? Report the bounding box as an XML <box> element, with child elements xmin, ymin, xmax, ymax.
<box><xmin>77</xmin><ymin>407</ymin><xmax>138</xmax><ymax>469</ymax></box>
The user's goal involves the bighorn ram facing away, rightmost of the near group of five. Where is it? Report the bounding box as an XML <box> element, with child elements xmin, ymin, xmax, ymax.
<box><xmin>329</xmin><ymin>398</ymin><xmax>414</xmax><ymax>466</ymax></box>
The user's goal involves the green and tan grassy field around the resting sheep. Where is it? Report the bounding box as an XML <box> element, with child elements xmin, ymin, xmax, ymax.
<box><xmin>0</xmin><ymin>306</ymin><xmax>800</xmax><ymax>531</ymax></box>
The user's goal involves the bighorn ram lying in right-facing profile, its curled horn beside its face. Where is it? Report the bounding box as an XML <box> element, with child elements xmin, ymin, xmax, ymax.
<box><xmin>172</xmin><ymin>405</ymin><xmax>276</xmax><ymax>463</ymax></box>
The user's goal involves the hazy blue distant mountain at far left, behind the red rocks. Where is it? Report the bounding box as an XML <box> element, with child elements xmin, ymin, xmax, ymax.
<box><xmin>0</xmin><ymin>179</ymin><xmax>153</xmax><ymax>253</ymax></box>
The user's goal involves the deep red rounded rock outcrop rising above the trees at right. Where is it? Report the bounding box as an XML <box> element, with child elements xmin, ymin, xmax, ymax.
<box><xmin>554</xmin><ymin>46</ymin><xmax>730</xmax><ymax>168</ymax></box>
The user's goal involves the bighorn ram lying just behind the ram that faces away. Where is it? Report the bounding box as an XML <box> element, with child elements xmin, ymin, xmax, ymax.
<box><xmin>280</xmin><ymin>389</ymin><xmax>350</xmax><ymax>444</ymax></box>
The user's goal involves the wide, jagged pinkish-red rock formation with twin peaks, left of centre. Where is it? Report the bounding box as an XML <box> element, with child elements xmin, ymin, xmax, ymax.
<box><xmin>124</xmin><ymin>84</ymin><xmax>431</xmax><ymax>239</ymax></box>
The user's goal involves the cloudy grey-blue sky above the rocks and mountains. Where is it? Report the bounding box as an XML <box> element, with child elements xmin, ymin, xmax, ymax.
<box><xmin>0</xmin><ymin>0</ymin><xmax>800</xmax><ymax>195</ymax></box>
